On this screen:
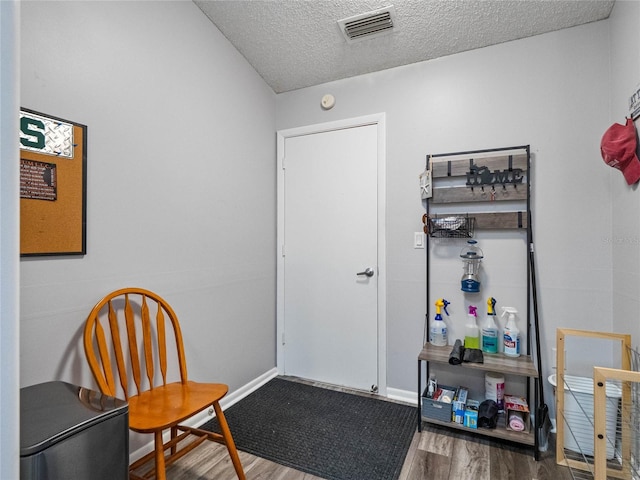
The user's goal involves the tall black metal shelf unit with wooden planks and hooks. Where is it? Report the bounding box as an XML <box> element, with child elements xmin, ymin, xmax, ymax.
<box><xmin>418</xmin><ymin>145</ymin><xmax>543</xmax><ymax>460</ymax></box>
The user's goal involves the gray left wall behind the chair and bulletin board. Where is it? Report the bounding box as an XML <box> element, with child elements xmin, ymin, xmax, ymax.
<box><xmin>20</xmin><ymin>1</ymin><xmax>276</xmax><ymax>440</ymax></box>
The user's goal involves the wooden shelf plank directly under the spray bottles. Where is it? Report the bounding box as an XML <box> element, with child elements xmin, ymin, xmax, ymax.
<box><xmin>418</xmin><ymin>343</ymin><xmax>538</xmax><ymax>378</ymax></box>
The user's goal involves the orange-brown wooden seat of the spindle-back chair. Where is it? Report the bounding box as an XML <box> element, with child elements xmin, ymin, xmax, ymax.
<box><xmin>128</xmin><ymin>381</ymin><xmax>229</xmax><ymax>433</ymax></box>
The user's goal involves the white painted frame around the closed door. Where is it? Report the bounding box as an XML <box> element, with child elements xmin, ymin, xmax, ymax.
<box><xmin>276</xmin><ymin>113</ymin><xmax>387</xmax><ymax>396</ymax></box>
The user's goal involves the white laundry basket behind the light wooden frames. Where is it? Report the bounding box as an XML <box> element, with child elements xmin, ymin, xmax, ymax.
<box><xmin>549</xmin><ymin>373</ymin><xmax>622</xmax><ymax>459</ymax></box>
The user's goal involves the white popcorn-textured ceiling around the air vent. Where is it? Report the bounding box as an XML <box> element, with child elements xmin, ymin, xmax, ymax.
<box><xmin>193</xmin><ymin>0</ymin><xmax>614</xmax><ymax>93</ymax></box>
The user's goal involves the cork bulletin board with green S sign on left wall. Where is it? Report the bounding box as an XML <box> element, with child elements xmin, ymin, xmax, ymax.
<box><xmin>20</xmin><ymin>108</ymin><xmax>87</xmax><ymax>257</ymax></box>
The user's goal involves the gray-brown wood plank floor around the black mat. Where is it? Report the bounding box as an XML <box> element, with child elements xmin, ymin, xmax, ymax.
<box><xmin>162</xmin><ymin>376</ymin><xmax>584</xmax><ymax>480</ymax></box>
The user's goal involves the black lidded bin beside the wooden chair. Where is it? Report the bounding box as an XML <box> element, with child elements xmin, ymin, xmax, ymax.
<box><xmin>20</xmin><ymin>381</ymin><xmax>129</xmax><ymax>480</ymax></box>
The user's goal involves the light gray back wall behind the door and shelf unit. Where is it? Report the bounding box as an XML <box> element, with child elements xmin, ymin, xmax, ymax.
<box><xmin>277</xmin><ymin>15</ymin><xmax>620</xmax><ymax>404</ymax></box>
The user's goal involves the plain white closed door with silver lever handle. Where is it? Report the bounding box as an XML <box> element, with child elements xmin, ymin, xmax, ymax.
<box><xmin>278</xmin><ymin>114</ymin><xmax>383</xmax><ymax>390</ymax></box>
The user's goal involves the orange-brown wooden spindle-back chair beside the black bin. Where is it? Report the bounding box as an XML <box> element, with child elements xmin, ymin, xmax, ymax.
<box><xmin>84</xmin><ymin>288</ymin><xmax>245</xmax><ymax>480</ymax></box>
